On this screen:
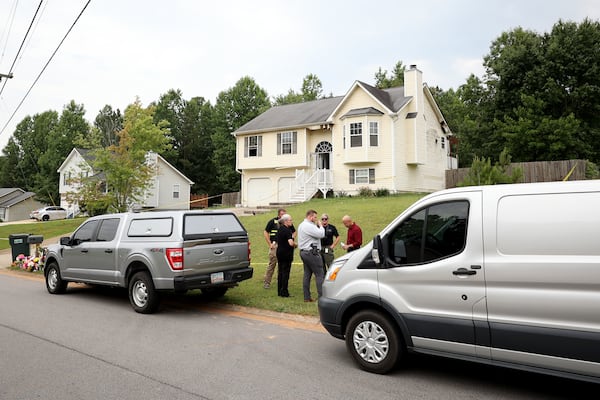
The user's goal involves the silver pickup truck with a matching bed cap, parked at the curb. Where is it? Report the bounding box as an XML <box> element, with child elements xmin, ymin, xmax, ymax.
<box><xmin>44</xmin><ymin>210</ymin><xmax>253</xmax><ymax>314</ymax></box>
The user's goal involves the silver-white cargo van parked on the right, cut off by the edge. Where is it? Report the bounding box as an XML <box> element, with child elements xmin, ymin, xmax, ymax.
<box><xmin>319</xmin><ymin>180</ymin><xmax>600</xmax><ymax>382</ymax></box>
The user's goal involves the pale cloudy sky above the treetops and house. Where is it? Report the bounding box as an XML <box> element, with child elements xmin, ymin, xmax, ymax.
<box><xmin>0</xmin><ymin>0</ymin><xmax>600</xmax><ymax>148</ymax></box>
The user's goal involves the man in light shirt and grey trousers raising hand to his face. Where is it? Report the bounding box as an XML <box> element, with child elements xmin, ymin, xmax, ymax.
<box><xmin>298</xmin><ymin>210</ymin><xmax>325</xmax><ymax>303</ymax></box>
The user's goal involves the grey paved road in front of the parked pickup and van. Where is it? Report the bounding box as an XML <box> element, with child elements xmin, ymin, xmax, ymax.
<box><xmin>0</xmin><ymin>269</ymin><xmax>597</xmax><ymax>400</ymax></box>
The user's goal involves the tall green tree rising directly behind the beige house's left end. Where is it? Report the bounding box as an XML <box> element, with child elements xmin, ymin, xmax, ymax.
<box><xmin>212</xmin><ymin>76</ymin><xmax>271</xmax><ymax>193</ymax></box>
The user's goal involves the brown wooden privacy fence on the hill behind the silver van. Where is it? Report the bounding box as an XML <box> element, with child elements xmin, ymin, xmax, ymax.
<box><xmin>446</xmin><ymin>160</ymin><xmax>586</xmax><ymax>188</ymax></box>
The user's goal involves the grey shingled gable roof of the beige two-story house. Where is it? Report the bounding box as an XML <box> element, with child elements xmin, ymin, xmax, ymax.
<box><xmin>232</xmin><ymin>81</ymin><xmax>412</xmax><ymax>136</ymax></box>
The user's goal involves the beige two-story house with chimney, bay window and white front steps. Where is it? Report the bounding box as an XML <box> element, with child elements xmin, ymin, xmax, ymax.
<box><xmin>233</xmin><ymin>65</ymin><xmax>457</xmax><ymax>207</ymax></box>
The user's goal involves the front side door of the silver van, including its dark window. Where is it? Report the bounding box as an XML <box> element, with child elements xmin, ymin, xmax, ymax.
<box><xmin>378</xmin><ymin>191</ymin><xmax>489</xmax><ymax>357</ymax></box>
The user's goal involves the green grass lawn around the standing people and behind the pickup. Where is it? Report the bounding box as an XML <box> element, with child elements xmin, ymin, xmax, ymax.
<box><xmin>0</xmin><ymin>194</ymin><xmax>423</xmax><ymax>315</ymax></box>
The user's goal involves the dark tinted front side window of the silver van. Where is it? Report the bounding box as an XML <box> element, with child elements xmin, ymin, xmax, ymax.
<box><xmin>388</xmin><ymin>201</ymin><xmax>469</xmax><ymax>264</ymax></box>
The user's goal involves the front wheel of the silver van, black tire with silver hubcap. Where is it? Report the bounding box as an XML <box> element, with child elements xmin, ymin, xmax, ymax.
<box><xmin>346</xmin><ymin>310</ymin><xmax>406</xmax><ymax>374</ymax></box>
